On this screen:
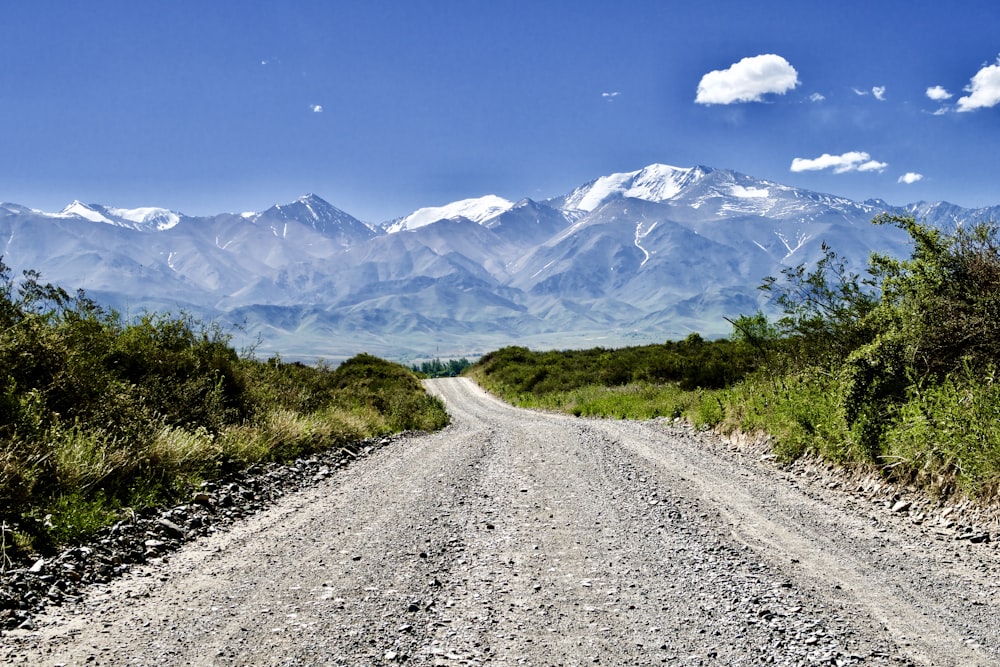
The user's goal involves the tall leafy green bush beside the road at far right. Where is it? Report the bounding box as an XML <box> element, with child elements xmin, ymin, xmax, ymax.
<box><xmin>733</xmin><ymin>214</ymin><xmax>1000</xmax><ymax>495</ymax></box>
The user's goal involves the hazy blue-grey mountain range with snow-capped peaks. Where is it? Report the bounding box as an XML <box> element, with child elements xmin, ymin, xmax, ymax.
<box><xmin>0</xmin><ymin>164</ymin><xmax>1000</xmax><ymax>360</ymax></box>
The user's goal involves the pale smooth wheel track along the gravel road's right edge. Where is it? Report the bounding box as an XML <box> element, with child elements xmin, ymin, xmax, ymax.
<box><xmin>584</xmin><ymin>423</ymin><xmax>1000</xmax><ymax>664</ymax></box>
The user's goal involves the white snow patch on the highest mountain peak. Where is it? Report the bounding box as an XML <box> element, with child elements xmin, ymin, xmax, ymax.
<box><xmin>563</xmin><ymin>164</ymin><xmax>705</xmax><ymax>212</ymax></box>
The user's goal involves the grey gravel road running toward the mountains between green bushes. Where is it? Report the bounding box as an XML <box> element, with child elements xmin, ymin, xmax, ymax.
<box><xmin>0</xmin><ymin>379</ymin><xmax>1000</xmax><ymax>665</ymax></box>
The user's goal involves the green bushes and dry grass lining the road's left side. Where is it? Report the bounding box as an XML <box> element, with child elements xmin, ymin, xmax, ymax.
<box><xmin>0</xmin><ymin>261</ymin><xmax>448</xmax><ymax>550</ymax></box>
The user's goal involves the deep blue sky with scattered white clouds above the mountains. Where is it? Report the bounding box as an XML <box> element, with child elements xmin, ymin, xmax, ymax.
<box><xmin>0</xmin><ymin>0</ymin><xmax>1000</xmax><ymax>222</ymax></box>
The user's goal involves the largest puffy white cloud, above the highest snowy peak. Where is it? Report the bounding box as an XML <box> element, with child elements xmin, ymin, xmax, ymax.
<box><xmin>694</xmin><ymin>53</ymin><xmax>799</xmax><ymax>104</ymax></box>
